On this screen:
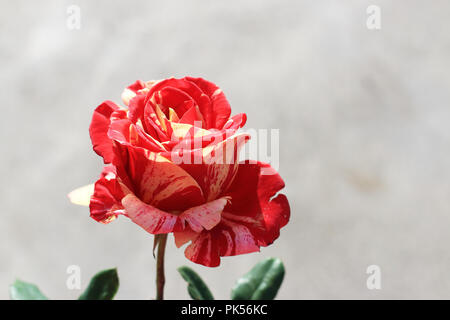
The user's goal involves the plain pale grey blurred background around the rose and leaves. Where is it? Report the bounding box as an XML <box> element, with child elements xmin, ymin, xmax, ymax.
<box><xmin>0</xmin><ymin>0</ymin><xmax>450</xmax><ymax>299</ymax></box>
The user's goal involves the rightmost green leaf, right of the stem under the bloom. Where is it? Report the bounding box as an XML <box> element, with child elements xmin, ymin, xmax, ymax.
<box><xmin>231</xmin><ymin>258</ymin><xmax>285</xmax><ymax>300</ymax></box>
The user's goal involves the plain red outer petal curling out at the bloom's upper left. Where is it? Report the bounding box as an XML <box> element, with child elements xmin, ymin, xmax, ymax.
<box><xmin>89</xmin><ymin>101</ymin><xmax>120</xmax><ymax>163</ymax></box>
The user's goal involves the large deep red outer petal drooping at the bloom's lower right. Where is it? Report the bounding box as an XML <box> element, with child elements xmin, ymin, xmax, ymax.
<box><xmin>175</xmin><ymin>161</ymin><xmax>290</xmax><ymax>267</ymax></box>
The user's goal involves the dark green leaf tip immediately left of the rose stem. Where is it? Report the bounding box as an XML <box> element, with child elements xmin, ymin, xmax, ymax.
<box><xmin>78</xmin><ymin>268</ymin><xmax>119</xmax><ymax>300</ymax></box>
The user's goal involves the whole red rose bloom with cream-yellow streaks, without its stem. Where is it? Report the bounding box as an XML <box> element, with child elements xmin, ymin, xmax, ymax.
<box><xmin>85</xmin><ymin>77</ymin><xmax>290</xmax><ymax>267</ymax></box>
